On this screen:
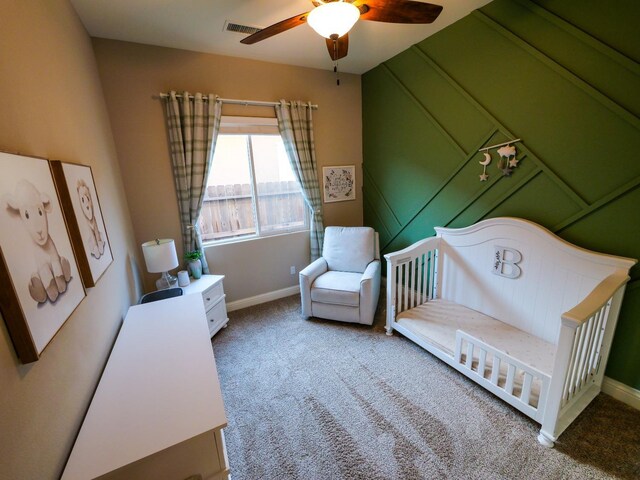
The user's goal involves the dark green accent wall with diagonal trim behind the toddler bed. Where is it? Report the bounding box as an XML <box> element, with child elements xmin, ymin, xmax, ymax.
<box><xmin>362</xmin><ymin>0</ymin><xmax>640</xmax><ymax>389</ymax></box>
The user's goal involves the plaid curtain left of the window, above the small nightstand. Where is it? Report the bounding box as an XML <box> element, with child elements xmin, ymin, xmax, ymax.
<box><xmin>164</xmin><ymin>91</ymin><xmax>222</xmax><ymax>273</ymax></box>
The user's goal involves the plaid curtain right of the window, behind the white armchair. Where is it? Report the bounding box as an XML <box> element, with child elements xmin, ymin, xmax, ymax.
<box><xmin>275</xmin><ymin>100</ymin><xmax>324</xmax><ymax>260</ymax></box>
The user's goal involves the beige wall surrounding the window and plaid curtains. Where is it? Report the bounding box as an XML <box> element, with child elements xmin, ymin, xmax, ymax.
<box><xmin>93</xmin><ymin>39</ymin><xmax>362</xmax><ymax>301</ymax></box>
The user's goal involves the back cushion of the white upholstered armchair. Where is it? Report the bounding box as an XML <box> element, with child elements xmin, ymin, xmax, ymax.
<box><xmin>322</xmin><ymin>227</ymin><xmax>376</xmax><ymax>273</ymax></box>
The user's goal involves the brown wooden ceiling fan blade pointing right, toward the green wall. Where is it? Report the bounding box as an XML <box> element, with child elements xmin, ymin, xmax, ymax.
<box><xmin>353</xmin><ymin>0</ymin><xmax>442</xmax><ymax>23</ymax></box>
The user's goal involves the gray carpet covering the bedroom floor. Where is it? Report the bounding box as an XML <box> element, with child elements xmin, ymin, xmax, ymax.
<box><xmin>213</xmin><ymin>296</ymin><xmax>640</xmax><ymax>480</ymax></box>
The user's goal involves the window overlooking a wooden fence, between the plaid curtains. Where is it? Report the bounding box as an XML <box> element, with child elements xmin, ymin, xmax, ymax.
<box><xmin>198</xmin><ymin>117</ymin><xmax>308</xmax><ymax>242</ymax></box>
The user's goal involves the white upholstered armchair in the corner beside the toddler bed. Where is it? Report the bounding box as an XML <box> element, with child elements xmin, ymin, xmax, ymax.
<box><xmin>300</xmin><ymin>227</ymin><xmax>380</xmax><ymax>325</ymax></box>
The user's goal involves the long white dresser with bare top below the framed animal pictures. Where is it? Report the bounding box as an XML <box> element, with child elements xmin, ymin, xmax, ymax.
<box><xmin>62</xmin><ymin>295</ymin><xmax>229</xmax><ymax>480</ymax></box>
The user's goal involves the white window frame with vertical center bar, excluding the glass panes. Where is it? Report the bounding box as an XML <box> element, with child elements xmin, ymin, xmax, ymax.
<box><xmin>197</xmin><ymin>115</ymin><xmax>310</xmax><ymax>247</ymax></box>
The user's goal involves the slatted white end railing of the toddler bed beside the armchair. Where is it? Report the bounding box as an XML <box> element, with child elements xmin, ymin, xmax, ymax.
<box><xmin>384</xmin><ymin>237</ymin><xmax>440</xmax><ymax>335</ymax></box>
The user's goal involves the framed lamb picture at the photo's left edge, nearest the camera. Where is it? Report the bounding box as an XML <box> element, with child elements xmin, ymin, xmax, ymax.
<box><xmin>0</xmin><ymin>152</ymin><xmax>85</xmax><ymax>363</ymax></box>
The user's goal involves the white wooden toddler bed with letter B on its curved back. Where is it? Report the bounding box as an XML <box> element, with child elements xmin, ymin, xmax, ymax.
<box><xmin>385</xmin><ymin>218</ymin><xmax>636</xmax><ymax>447</ymax></box>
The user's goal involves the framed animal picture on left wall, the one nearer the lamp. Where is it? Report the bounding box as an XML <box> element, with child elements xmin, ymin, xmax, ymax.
<box><xmin>50</xmin><ymin>160</ymin><xmax>113</xmax><ymax>288</ymax></box>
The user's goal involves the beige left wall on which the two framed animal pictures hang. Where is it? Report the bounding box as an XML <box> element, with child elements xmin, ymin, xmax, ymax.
<box><xmin>0</xmin><ymin>0</ymin><xmax>139</xmax><ymax>480</ymax></box>
